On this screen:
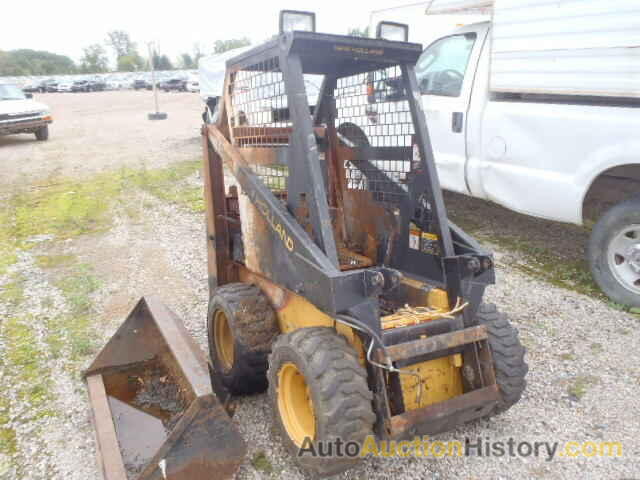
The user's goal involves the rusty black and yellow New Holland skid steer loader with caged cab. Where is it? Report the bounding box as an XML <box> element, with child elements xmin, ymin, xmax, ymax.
<box><xmin>202</xmin><ymin>18</ymin><xmax>527</xmax><ymax>475</ymax></box>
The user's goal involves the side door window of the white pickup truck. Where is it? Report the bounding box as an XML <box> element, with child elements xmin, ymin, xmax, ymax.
<box><xmin>416</xmin><ymin>33</ymin><xmax>476</xmax><ymax>97</ymax></box>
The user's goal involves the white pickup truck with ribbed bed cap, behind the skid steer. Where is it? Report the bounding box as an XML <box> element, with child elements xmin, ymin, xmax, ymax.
<box><xmin>412</xmin><ymin>0</ymin><xmax>640</xmax><ymax>307</ymax></box>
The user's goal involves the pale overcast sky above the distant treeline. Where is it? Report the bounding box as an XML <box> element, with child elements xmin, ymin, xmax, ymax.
<box><xmin>0</xmin><ymin>0</ymin><xmax>428</xmax><ymax>66</ymax></box>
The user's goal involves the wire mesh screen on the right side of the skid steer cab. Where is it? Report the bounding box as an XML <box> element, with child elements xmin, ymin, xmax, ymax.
<box><xmin>334</xmin><ymin>66</ymin><xmax>414</xmax><ymax>204</ymax></box>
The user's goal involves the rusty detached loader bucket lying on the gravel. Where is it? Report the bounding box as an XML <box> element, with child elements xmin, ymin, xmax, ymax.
<box><xmin>85</xmin><ymin>297</ymin><xmax>246</xmax><ymax>480</ymax></box>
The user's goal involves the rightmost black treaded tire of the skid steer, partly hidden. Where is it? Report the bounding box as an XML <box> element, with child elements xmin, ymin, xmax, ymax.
<box><xmin>476</xmin><ymin>303</ymin><xmax>529</xmax><ymax>416</ymax></box>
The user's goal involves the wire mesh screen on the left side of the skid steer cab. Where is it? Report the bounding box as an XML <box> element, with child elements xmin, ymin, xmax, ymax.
<box><xmin>229</xmin><ymin>57</ymin><xmax>291</xmax><ymax>192</ymax></box>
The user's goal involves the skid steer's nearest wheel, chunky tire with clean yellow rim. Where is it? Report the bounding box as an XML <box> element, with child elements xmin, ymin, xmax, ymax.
<box><xmin>268</xmin><ymin>327</ymin><xmax>376</xmax><ymax>476</ymax></box>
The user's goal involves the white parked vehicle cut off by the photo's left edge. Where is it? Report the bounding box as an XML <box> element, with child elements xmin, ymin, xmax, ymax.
<box><xmin>0</xmin><ymin>83</ymin><xmax>53</xmax><ymax>141</ymax></box>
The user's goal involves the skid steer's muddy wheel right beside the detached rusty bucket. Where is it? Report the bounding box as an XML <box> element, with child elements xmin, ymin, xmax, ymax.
<box><xmin>207</xmin><ymin>283</ymin><xmax>279</xmax><ymax>395</ymax></box>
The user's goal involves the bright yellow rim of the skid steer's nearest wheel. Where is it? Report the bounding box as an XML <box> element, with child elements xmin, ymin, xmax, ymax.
<box><xmin>278</xmin><ymin>363</ymin><xmax>316</xmax><ymax>447</ymax></box>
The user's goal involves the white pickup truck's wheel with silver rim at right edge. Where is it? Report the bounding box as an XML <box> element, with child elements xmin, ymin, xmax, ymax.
<box><xmin>587</xmin><ymin>197</ymin><xmax>640</xmax><ymax>308</ymax></box>
